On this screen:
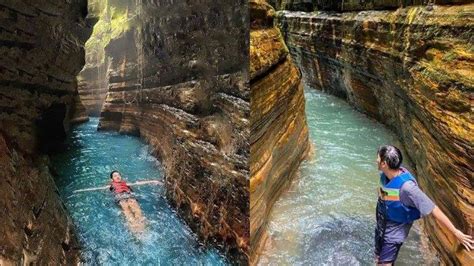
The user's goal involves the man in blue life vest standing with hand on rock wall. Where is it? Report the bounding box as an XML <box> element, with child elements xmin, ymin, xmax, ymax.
<box><xmin>375</xmin><ymin>145</ymin><xmax>474</xmax><ymax>265</ymax></box>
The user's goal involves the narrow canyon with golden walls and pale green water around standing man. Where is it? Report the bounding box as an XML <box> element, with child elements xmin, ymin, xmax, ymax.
<box><xmin>250</xmin><ymin>0</ymin><xmax>474</xmax><ymax>265</ymax></box>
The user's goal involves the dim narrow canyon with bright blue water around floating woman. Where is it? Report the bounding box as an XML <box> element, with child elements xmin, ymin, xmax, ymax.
<box><xmin>0</xmin><ymin>0</ymin><xmax>250</xmax><ymax>265</ymax></box>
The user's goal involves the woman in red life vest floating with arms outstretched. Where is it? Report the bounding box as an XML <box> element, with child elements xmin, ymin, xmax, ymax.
<box><xmin>74</xmin><ymin>170</ymin><xmax>163</xmax><ymax>234</ymax></box>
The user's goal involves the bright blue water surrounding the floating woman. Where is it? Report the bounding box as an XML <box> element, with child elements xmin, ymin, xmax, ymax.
<box><xmin>52</xmin><ymin>118</ymin><xmax>227</xmax><ymax>265</ymax></box>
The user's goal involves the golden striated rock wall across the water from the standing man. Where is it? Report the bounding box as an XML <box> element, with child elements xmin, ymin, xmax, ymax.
<box><xmin>250</xmin><ymin>0</ymin><xmax>309</xmax><ymax>264</ymax></box>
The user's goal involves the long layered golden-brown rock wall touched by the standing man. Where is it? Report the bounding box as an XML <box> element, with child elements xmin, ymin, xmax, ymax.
<box><xmin>278</xmin><ymin>1</ymin><xmax>474</xmax><ymax>265</ymax></box>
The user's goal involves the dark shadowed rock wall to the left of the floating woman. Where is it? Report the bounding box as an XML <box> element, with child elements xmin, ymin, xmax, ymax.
<box><xmin>0</xmin><ymin>0</ymin><xmax>92</xmax><ymax>265</ymax></box>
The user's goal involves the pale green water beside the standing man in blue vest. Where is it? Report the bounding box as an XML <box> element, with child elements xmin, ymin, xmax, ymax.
<box><xmin>260</xmin><ymin>88</ymin><xmax>434</xmax><ymax>265</ymax></box>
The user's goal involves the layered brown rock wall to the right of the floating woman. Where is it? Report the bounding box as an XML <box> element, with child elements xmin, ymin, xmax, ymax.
<box><xmin>99</xmin><ymin>0</ymin><xmax>250</xmax><ymax>263</ymax></box>
